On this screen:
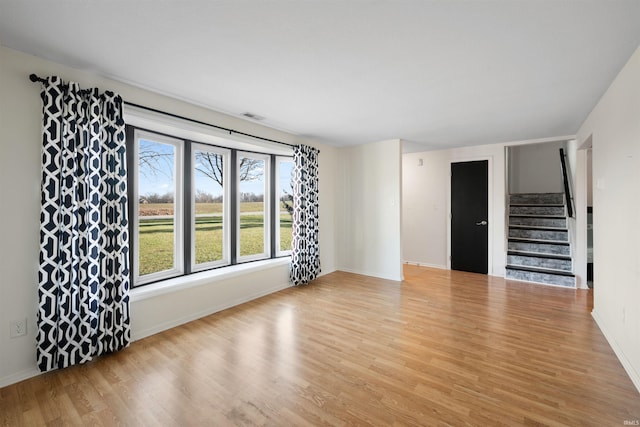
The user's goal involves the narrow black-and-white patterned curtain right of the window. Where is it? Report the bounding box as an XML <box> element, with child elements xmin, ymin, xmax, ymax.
<box><xmin>289</xmin><ymin>145</ymin><xmax>320</xmax><ymax>286</ymax></box>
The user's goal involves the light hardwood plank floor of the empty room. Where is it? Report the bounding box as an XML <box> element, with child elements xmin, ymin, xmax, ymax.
<box><xmin>0</xmin><ymin>266</ymin><xmax>640</xmax><ymax>426</ymax></box>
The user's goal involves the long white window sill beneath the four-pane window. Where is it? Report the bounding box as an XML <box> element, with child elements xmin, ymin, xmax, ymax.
<box><xmin>129</xmin><ymin>257</ymin><xmax>291</xmax><ymax>302</ymax></box>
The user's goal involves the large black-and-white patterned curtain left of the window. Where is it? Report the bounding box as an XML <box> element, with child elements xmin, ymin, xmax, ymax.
<box><xmin>37</xmin><ymin>76</ymin><xmax>130</xmax><ymax>371</ymax></box>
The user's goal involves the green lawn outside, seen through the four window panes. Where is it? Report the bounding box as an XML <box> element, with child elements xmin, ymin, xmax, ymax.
<box><xmin>139</xmin><ymin>211</ymin><xmax>291</xmax><ymax>275</ymax></box>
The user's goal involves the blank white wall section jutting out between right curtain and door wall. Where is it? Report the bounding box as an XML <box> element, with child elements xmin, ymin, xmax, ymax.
<box><xmin>337</xmin><ymin>139</ymin><xmax>402</xmax><ymax>280</ymax></box>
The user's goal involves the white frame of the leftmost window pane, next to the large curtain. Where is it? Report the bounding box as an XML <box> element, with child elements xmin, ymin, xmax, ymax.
<box><xmin>129</xmin><ymin>127</ymin><xmax>185</xmax><ymax>286</ymax></box>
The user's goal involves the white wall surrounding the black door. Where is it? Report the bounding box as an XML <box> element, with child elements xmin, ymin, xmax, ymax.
<box><xmin>402</xmin><ymin>144</ymin><xmax>506</xmax><ymax>276</ymax></box>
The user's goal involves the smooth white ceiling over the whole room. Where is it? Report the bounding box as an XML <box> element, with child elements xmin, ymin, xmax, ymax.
<box><xmin>0</xmin><ymin>0</ymin><xmax>640</xmax><ymax>151</ymax></box>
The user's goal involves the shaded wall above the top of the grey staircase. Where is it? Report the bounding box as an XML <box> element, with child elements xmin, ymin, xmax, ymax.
<box><xmin>509</xmin><ymin>142</ymin><xmax>566</xmax><ymax>194</ymax></box>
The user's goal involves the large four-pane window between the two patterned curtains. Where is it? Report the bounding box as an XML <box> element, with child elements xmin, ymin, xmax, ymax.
<box><xmin>127</xmin><ymin>121</ymin><xmax>293</xmax><ymax>286</ymax></box>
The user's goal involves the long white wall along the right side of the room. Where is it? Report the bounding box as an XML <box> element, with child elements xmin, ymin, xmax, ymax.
<box><xmin>576</xmin><ymin>48</ymin><xmax>640</xmax><ymax>390</ymax></box>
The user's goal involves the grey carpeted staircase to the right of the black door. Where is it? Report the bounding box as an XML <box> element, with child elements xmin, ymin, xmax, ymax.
<box><xmin>506</xmin><ymin>193</ymin><xmax>575</xmax><ymax>287</ymax></box>
